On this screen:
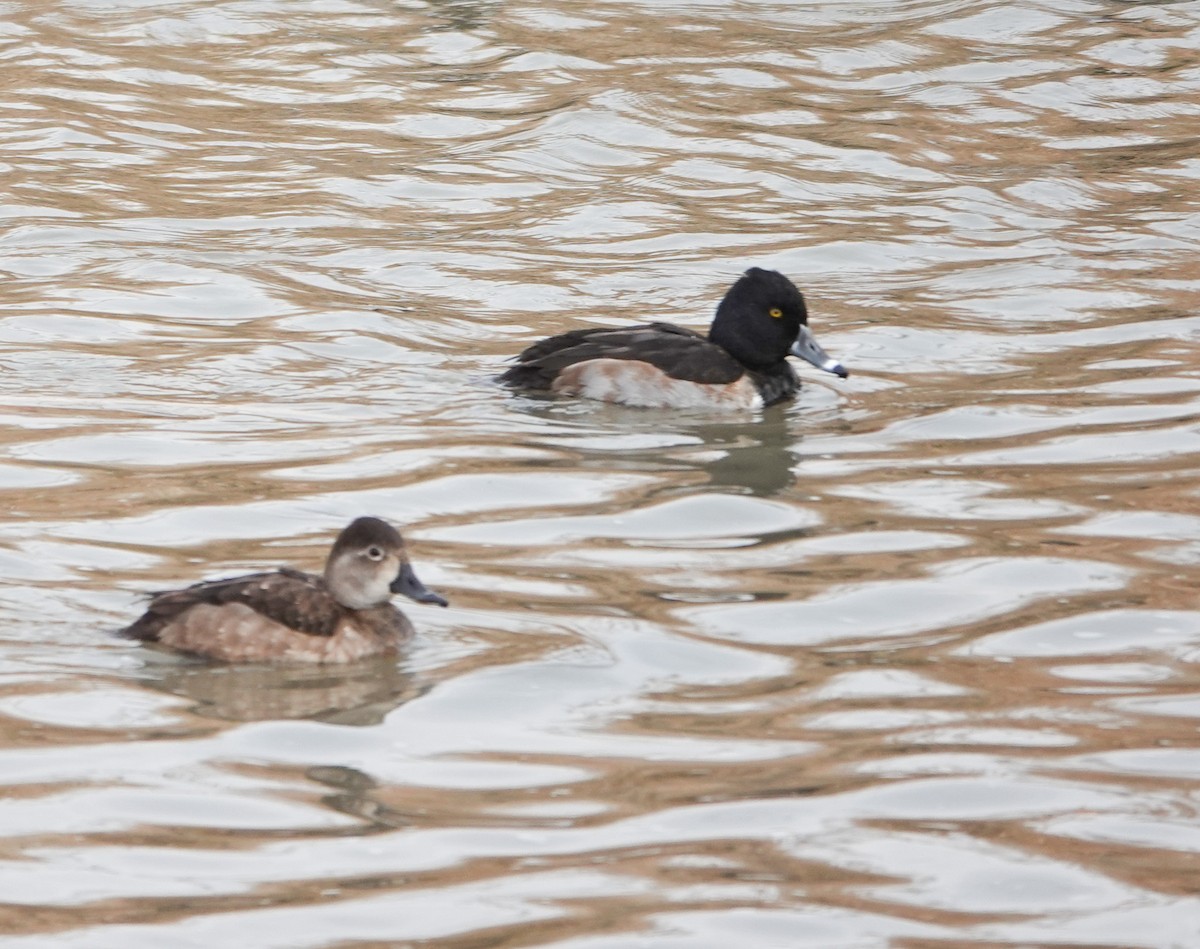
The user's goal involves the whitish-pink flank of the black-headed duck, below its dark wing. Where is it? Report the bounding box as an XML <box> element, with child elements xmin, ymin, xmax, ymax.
<box><xmin>551</xmin><ymin>359</ymin><xmax>762</xmax><ymax>409</ymax></box>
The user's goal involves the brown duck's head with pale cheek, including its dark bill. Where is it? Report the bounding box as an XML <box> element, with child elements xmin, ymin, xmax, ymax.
<box><xmin>325</xmin><ymin>517</ymin><xmax>446</xmax><ymax>609</ymax></box>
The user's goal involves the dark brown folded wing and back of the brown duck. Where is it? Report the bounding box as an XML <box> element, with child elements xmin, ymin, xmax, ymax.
<box><xmin>122</xmin><ymin>567</ymin><xmax>346</xmax><ymax>641</ymax></box>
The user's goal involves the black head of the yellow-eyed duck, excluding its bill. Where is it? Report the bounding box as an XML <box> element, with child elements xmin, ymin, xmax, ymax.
<box><xmin>708</xmin><ymin>266</ymin><xmax>809</xmax><ymax>370</ymax></box>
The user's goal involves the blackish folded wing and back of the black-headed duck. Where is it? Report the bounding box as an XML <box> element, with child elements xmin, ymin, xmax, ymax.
<box><xmin>499</xmin><ymin>323</ymin><xmax>744</xmax><ymax>389</ymax></box>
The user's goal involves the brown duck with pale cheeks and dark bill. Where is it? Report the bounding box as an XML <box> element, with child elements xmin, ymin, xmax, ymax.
<box><xmin>121</xmin><ymin>517</ymin><xmax>448</xmax><ymax>663</ymax></box>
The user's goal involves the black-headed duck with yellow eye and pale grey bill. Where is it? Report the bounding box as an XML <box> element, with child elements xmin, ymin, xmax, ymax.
<box><xmin>498</xmin><ymin>266</ymin><xmax>850</xmax><ymax>409</ymax></box>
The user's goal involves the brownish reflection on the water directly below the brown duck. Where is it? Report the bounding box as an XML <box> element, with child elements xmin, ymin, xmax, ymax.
<box><xmin>134</xmin><ymin>660</ymin><xmax>421</xmax><ymax>725</ymax></box>
